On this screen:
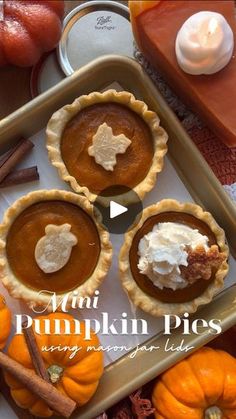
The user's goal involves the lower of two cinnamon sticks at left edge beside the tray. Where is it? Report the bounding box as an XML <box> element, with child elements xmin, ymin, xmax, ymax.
<box><xmin>0</xmin><ymin>167</ymin><xmax>39</xmax><ymax>188</ymax></box>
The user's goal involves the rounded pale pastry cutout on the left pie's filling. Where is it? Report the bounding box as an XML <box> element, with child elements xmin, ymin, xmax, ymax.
<box><xmin>35</xmin><ymin>224</ymin><xmax>78</xmax><ymax>273</ymax></box>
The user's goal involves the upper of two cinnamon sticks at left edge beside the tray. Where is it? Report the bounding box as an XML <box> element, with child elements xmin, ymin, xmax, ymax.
<box><xmin>0</xmin><ymin>139</ymin><xmax>34</xmax><ymax>182</ymax></box>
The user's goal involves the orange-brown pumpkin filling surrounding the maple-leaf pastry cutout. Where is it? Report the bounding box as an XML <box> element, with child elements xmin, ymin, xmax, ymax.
<box><xmin>61</xmin><ymin>102</ymin><xmax>154</xmax><ymax>194</ymax></box>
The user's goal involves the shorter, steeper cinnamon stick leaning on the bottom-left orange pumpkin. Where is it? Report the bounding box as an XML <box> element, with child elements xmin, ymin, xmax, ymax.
<box><xmin>22</xmin><ymin>323</ymin><xmax>50</xmax><ymax>383</ymax></box>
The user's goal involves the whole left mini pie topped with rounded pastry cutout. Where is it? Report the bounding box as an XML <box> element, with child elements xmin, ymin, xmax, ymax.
<box><xmin>0</xmin><ymin>190</ymin><xmax>112</xmax><ymax>307</ymax></box>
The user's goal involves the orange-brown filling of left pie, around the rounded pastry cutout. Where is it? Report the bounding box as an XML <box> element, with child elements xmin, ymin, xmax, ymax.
<box><xmin>6</xmin><ymin>200</ymin><xmax>101</xmax><ymax>293</ymax></box>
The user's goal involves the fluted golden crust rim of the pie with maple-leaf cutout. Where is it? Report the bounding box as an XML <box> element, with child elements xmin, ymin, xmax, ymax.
<box><xmin>46</xmin><ymin>89</ymin><xmax>168</xmax><ymax>205</ymax></box>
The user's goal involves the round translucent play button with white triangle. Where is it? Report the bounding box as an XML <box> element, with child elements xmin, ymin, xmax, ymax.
<box><xmin>94</xmin><ymin>185</ymin><xmax>143</xmax><ymax>234</ymax></box>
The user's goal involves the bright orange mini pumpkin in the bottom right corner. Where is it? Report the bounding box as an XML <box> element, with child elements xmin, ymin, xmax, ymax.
<box><xmin>152</xmin><ymin>348</ymin><xmax>236</xmax><ymax>419</ymax></box>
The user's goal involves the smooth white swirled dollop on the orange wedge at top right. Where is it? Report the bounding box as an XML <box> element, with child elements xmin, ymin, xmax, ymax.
<box><xmin>175</xmin><ymin>11</ymin><xmax>234</xmax><ymax>74</ymax></box>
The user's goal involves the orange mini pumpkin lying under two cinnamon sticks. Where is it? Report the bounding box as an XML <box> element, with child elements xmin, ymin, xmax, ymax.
<box><xmin>5</xmin><ymin>313</ymin><xmax>103</xmax><ymax>417</ymax></box>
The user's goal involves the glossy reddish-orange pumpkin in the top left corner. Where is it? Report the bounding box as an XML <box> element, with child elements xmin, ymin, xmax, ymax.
<box><xmin>0</xmin><ymin>0</ymin><xmax>64</xmax><ymax>67</ymax></box>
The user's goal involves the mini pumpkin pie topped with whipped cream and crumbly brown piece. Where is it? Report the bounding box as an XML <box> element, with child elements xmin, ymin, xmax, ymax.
<box><xmin>119</xmin><ymin>199</ymin><xmax>228</xmax><ymax>316</ymax></box>
